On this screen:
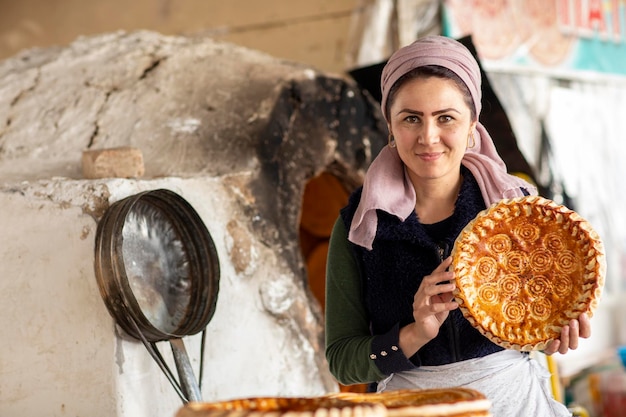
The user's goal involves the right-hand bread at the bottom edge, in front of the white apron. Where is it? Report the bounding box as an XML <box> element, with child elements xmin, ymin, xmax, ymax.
<box><xmin>335</xmin><ymin>387</ymin><xmax>491</xmax><ymax>417</ymax></box>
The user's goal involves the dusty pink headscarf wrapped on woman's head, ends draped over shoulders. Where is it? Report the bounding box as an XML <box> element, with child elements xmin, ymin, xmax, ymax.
<box><xmin>348</xmin><ymin>36</ymin><xmax>537</xmax><ymax>250</ymax></box>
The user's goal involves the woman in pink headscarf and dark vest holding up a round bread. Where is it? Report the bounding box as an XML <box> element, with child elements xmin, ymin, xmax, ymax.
<box><xmin>326</xmin><ymin>36</ymin><xmax>591</xmax><ymax>417</ymax></box>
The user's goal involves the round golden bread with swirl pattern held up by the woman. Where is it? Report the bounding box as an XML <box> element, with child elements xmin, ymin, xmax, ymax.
<box><xmin>452</xmin><ymin>196</ymin><xmax>606</xmax><ymax>351</ymax></box>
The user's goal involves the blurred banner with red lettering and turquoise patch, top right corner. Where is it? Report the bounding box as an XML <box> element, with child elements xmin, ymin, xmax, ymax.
<box><xmin>443</xmin><ymin>0</ymin><xmax>626</xmax><ymax>77</ymax></box>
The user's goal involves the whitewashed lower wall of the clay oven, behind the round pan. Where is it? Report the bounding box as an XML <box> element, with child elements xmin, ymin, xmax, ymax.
<box><xmin>0</xmin><ymin>176</ymin><xmax>332</xmax><ymax>417</ymax></box>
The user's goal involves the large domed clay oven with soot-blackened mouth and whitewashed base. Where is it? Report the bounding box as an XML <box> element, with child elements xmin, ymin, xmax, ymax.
<box><xmin>0</xmin><ymin>32</ymin><xmax>386</xmax><ymax>416</ymax></box>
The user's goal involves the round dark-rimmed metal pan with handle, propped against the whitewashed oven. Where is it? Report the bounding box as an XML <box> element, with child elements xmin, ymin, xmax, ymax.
<box><xmin>95</xmin><ymin>189</ymin><xmax>220</xmax><ymax>401</ymax></box>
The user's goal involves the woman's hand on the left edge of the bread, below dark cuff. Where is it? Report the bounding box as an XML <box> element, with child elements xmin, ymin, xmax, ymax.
<box><xmin>400</xmin><ymin>257</ymin><xmax>459</xmax><ymax>358</ymax></box>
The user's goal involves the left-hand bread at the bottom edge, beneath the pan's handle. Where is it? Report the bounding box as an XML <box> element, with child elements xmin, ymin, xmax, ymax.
<box><xmin>176</xmin><ymin>396</ymin><xmax>387</xmax><ymax>417</ymax></box>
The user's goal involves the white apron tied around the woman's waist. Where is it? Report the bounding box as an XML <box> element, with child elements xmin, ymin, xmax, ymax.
<box><xmin>377</xmin><ymin>350</ymin><xmax>572</xmax><ymax>417</ymax></box>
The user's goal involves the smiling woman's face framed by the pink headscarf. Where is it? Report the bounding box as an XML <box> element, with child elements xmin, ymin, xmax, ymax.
<box><xmin>389</xmin><ymin>77</ymin><xmax>476</xmax><ymax>184</ymax></box>
